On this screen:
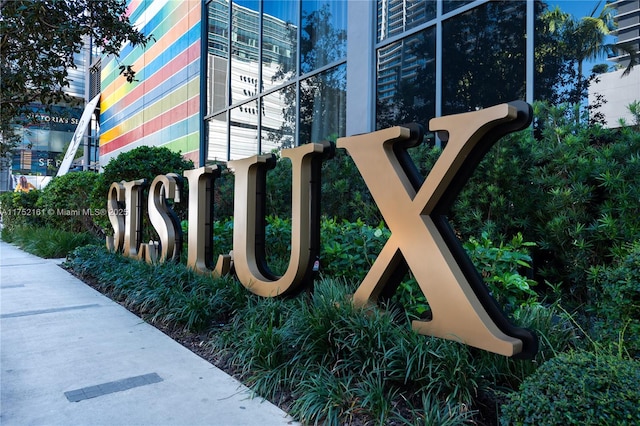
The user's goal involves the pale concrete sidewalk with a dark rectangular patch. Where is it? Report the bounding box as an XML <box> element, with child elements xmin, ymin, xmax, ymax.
<box><xmin>0</xmin><ymin>242</ymin><xmax>294</xmax><ymax>426</ymax></box>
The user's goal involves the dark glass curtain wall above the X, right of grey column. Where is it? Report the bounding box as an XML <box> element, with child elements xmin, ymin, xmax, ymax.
<box><xmin>376</xmin><ymin>0</ymin><xmax>532</xmax><ymax>129</ymax></box>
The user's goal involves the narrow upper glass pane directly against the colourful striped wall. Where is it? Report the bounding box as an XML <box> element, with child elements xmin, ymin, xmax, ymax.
<box><xmin>207</xmin><ymin>0</ymin><xmax>229</xmax><ymax>114</ymax></box>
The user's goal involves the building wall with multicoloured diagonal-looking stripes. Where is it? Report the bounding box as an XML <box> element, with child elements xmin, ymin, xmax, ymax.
<box><xmin>100</xmin><ymin>0</ymin><xmax>201</xmax><ymax>165</ymax></box>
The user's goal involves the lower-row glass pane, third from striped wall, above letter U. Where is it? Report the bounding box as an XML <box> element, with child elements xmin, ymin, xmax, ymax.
<box><xmin>260</xmin><ymin>84</ymin><xmax>296</xmax><ymax>153</ymax></box>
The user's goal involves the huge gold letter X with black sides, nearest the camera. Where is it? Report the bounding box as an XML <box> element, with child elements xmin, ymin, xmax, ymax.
<box><xmin>338</xmin><ymin>102</ymin><xmax>537</xmax><ymax>356</ymax></box>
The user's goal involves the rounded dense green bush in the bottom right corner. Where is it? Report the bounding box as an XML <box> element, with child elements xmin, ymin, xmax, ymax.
<box><xmin>500</xmin><ymin>352</ymin><xmax>640</xmax><ymax>426</ymax></box>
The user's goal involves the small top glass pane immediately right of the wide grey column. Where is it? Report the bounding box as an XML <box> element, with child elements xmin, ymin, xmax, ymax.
<box><xmin>378</xmin><ymin>0</ymin><xmax>436</xmax><ymax>41</ymax></box>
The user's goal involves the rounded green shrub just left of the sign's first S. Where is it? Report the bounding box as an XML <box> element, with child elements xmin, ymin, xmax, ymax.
<box><xmin>37</xmin><ymin>172</ymin><xmax>101</xmax><ymax>232</ymax></box>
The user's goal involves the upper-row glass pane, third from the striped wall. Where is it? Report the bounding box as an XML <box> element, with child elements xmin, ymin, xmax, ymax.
<box><xmin>262</xmin><ymin>1</ymin><xmax>299</xmax><ymax>90</ymax></box>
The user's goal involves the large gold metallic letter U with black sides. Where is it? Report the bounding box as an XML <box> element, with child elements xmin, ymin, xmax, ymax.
<box><xmin>229</xmin><ymin>142</ymin><xmax>332</xmax><ymax>297</ymax></box>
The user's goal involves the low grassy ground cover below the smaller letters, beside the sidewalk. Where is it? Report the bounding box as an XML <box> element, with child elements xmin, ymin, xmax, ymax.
<box><xmin>66</xmin><ymin>246</ymin><xmax>247</xmax><ymax>331</ymax></box>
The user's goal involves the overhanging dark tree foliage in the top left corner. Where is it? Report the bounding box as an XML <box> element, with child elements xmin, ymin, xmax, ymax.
<box><xmin>0</xmin><ymin>0</ymin><xmax>151</xmax><ymax>154</ymax></box>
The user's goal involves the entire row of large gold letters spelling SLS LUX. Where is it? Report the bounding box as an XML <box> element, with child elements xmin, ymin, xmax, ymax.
<box><xmin>107</xmin><ymin>101</ymin><xmax>538</xmax><ymax>357</ymax></box>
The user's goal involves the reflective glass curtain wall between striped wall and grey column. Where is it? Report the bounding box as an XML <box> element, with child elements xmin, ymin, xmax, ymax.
<box><xmin>206</xmin><ymin>0</ymin><xmax>347</xmax><ymax>162</ymax></box>
